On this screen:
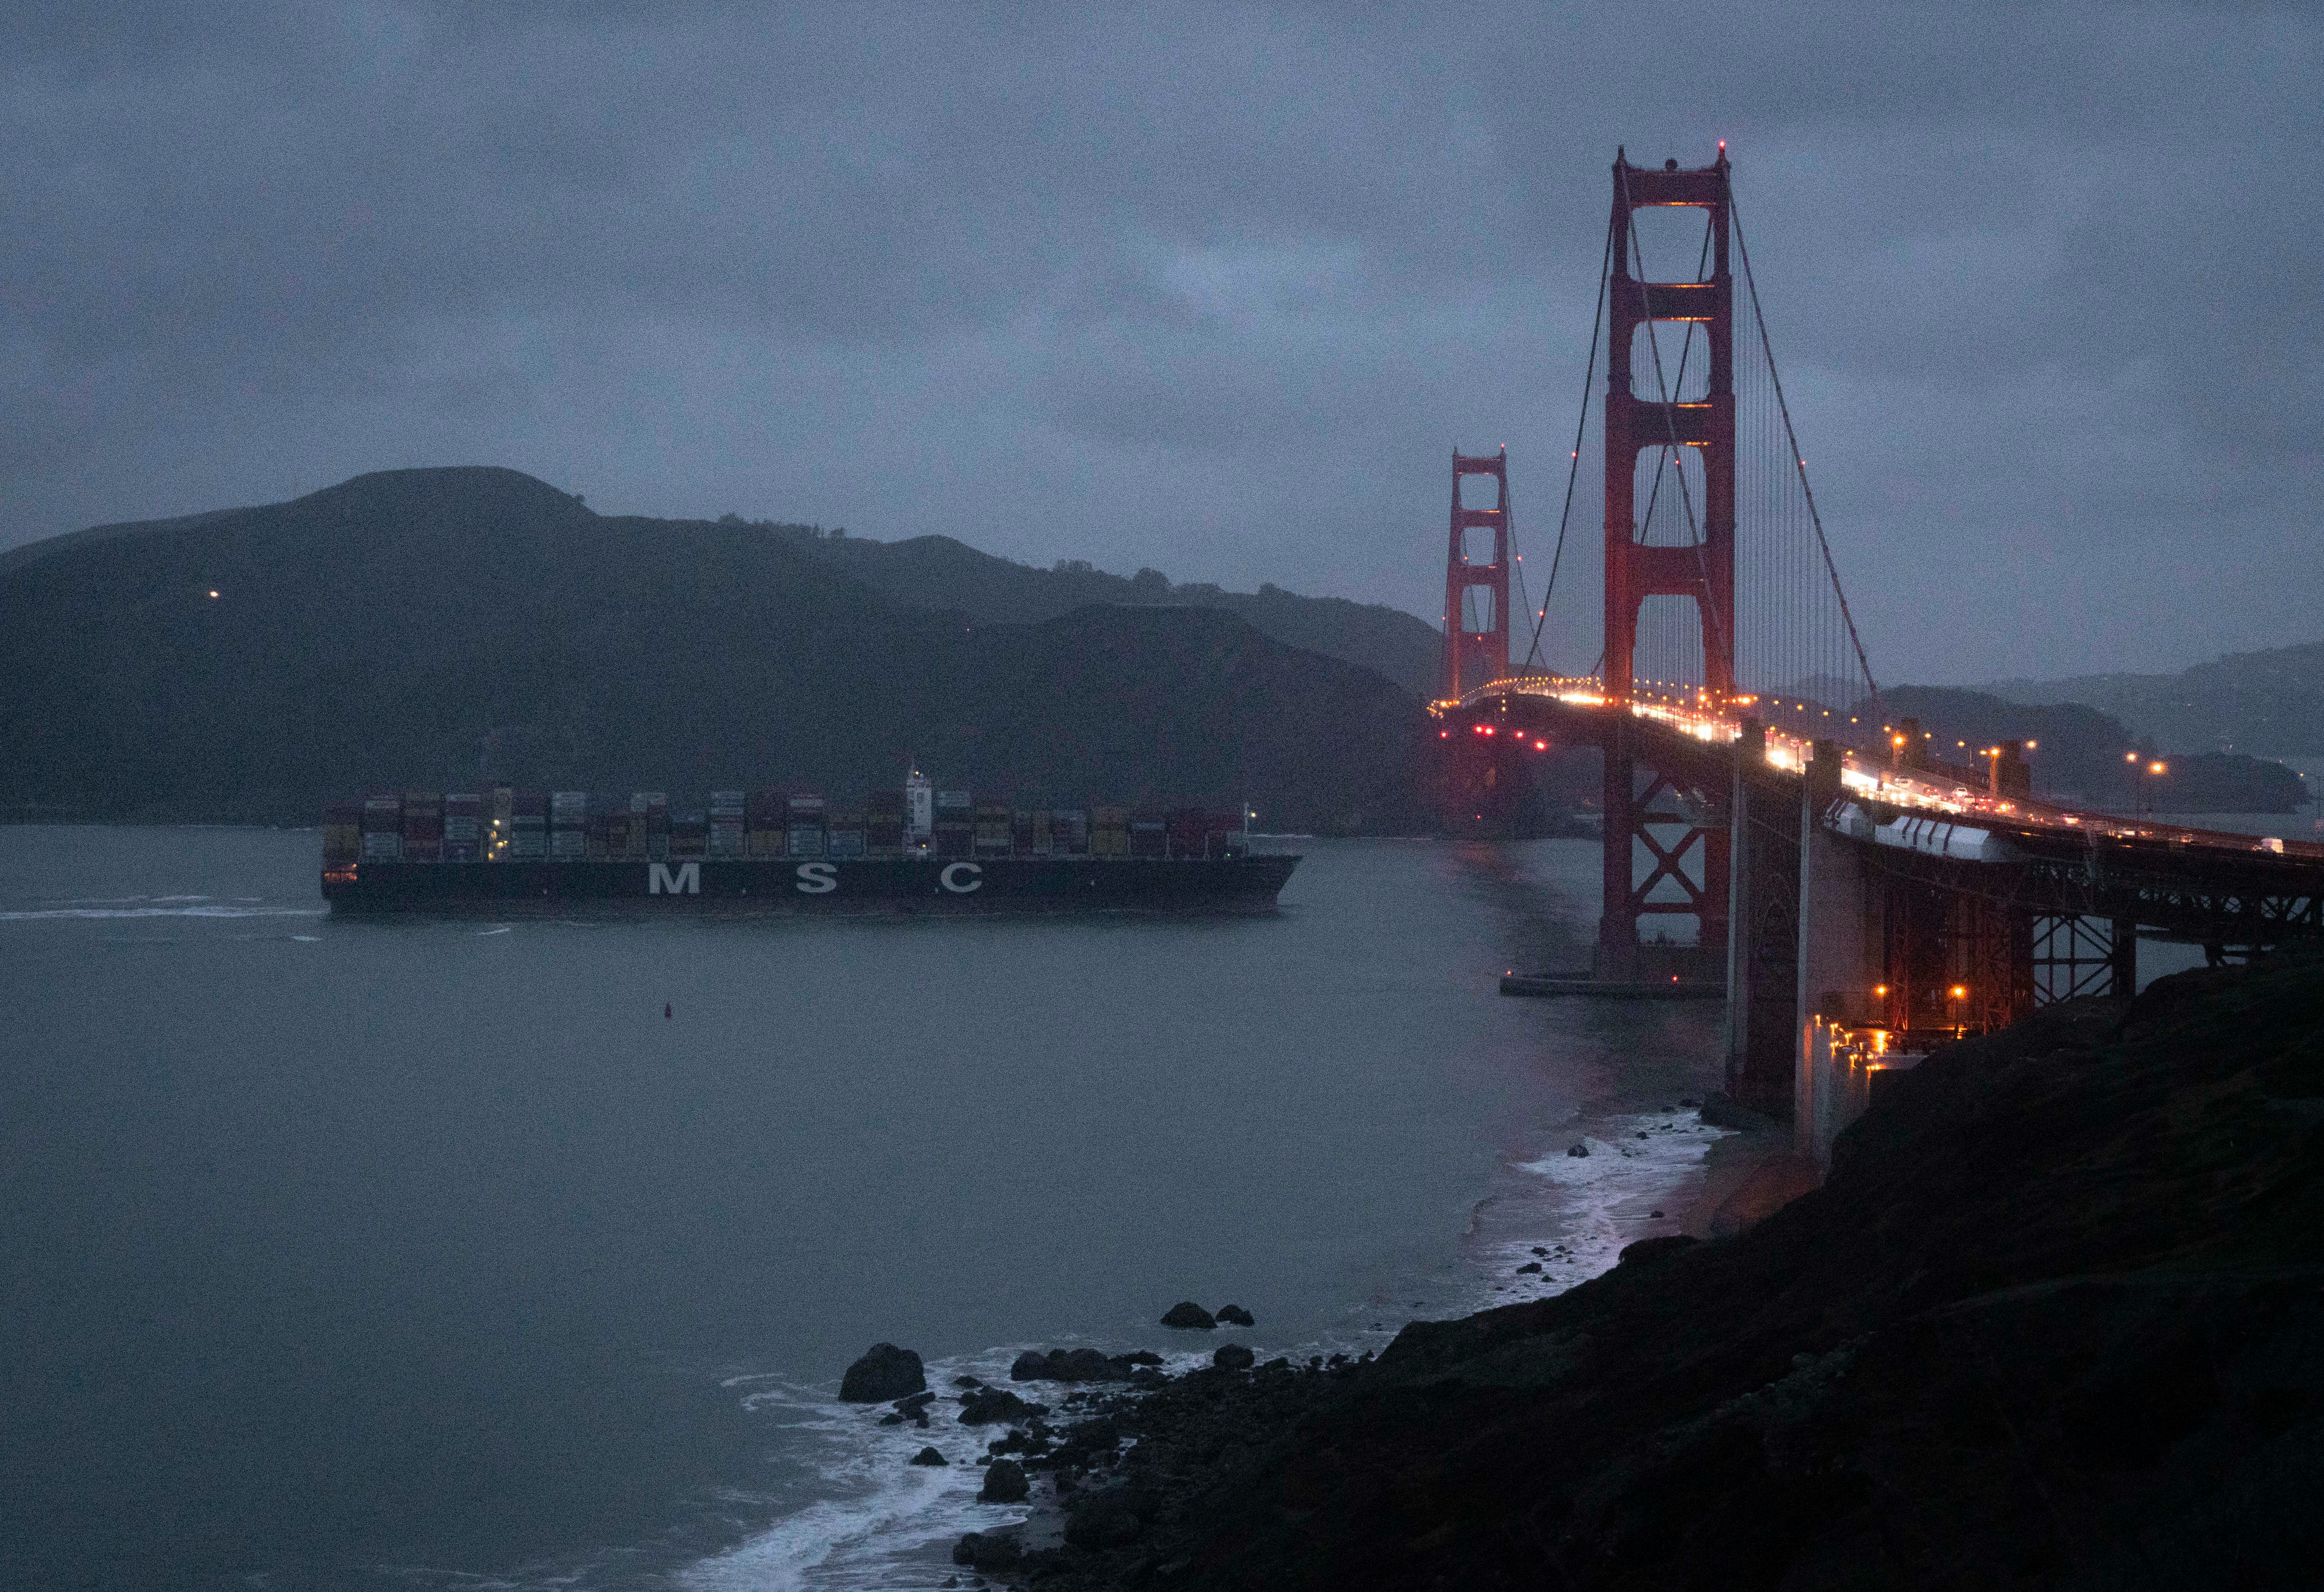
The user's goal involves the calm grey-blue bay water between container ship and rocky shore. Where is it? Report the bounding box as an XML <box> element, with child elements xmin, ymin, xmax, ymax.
<box><xmin>0</xmin><ymin>827</ymin><xmax>1717</xmax><ymax>1587</ymax></box>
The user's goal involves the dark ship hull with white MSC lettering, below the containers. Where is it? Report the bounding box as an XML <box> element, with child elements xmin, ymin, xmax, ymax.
<box><xmin>323</xmin><ymin>855</ymin><xmax>1299</xmax><ymax>911</ymax></box>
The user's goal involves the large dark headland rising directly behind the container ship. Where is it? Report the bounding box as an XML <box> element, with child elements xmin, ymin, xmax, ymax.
<box><xmin>0</xmin><ymin>469</ymin><xmax>1420</xmax><ymax>827</ymax></box>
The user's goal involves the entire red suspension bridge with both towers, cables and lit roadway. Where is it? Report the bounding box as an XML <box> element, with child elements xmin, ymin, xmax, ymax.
<box><xmin>1432</xmin><ymin>144</ymin><xmax>2324</xmax><ymax>1155</ymax></box>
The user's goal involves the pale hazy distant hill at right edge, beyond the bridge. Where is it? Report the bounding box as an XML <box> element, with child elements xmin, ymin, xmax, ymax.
<box><xmin>1985</xmin><ymin>642</ymin><xmax>2324</xmax><ymax>758</ymax></box>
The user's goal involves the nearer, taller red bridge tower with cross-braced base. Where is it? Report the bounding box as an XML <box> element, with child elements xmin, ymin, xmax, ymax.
<box><xmin>1599</xmin><ymin>146</ymin><xmax>1736</xmax><ymax>979</ymax></box>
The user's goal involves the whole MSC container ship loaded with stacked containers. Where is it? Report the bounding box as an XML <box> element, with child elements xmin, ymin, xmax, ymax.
<box><xmin>323</xmin><ymin>774</ymin><xmax>1299</xmax><ymax>909</ymax></box>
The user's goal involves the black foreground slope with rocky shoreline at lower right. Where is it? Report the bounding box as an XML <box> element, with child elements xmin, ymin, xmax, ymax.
<box><xmin>878</xmin><ymin>960</ymin><xmax>2324</xmax><ymax>1592</ymax></box>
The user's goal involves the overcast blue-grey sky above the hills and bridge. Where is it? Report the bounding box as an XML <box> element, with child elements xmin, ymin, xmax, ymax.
<box><xmin>0</xmin><ymin>0</ymin><xmax>2324</xmax><ymax>681</ymax></box>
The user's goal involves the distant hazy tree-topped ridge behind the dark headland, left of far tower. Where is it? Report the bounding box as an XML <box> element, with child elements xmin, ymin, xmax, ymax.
<box><xmin>804</xmin><ymin>537</ymin><xmax>1443</xmax><ymax>702</ymax></box>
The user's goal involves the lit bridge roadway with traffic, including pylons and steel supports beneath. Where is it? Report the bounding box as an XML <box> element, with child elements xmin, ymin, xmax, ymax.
<box><xmin>1432</xmin><ymin>676</ymin><xmax>2324</xmax><ymax>1129</ymax></box>
